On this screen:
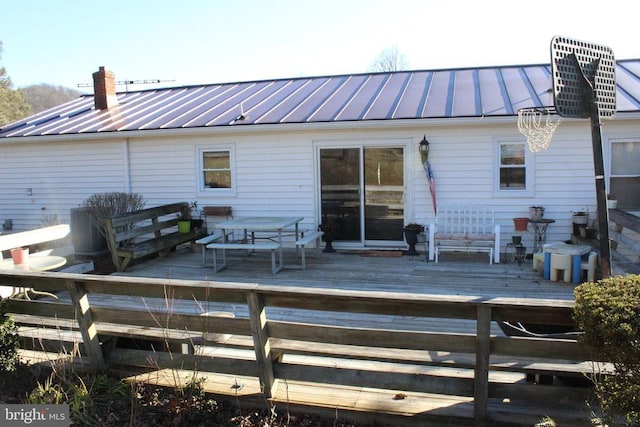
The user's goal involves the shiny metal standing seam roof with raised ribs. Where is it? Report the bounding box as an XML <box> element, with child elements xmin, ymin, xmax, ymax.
<box><xmin>0</xmin><ymin>59</ymin><xmax>640</xmax><ymax>138</ymax></box>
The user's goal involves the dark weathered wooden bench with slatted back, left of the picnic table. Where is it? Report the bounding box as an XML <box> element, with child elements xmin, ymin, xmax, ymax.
<box><xmin>105</xmin><ymin>202</ymin><xmax>206</xmax><ymax>271</ymax></box>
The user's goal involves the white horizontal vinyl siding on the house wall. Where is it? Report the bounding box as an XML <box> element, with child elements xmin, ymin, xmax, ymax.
<box><xmin>0</xmin><ymin>117</ymin><xmax>638</xmax><ymax>254</ymax></box>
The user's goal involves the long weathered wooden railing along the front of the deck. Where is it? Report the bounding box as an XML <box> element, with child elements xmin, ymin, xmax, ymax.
<box><xmin>0</xmin><ymin>272</ymin><xmax>594</xmax><ymax>425</ymax></box>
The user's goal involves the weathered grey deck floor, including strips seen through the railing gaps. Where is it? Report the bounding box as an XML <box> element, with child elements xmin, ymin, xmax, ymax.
<box><xmin>101</xmin><ymin>247</ymin><xmax>575</xmax><ymax>335</ymax></box>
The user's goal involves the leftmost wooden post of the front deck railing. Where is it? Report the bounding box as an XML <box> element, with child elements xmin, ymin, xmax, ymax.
<box><xmin>67</xmin><ymin>282</ymin><xmax>107</xmax><ymax>371</ymax></box>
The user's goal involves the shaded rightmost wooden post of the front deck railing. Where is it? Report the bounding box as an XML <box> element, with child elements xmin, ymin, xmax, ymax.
<box><xmin>473</xmin><ymin>305</ymin><xmax>491</xmax><ymax>423</ymax></box>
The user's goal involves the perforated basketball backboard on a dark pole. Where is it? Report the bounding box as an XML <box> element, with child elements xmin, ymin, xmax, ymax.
<box><xmin>551</xmin><ymin>36</ymin><xmax>616</xmax><ymax>118</ymax></box>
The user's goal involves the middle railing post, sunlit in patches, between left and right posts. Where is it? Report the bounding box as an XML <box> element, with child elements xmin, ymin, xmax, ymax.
<box><xmin>247</xmin><ymin>292</ymin><xmax>275</xmax><ymax>399</ymax></box>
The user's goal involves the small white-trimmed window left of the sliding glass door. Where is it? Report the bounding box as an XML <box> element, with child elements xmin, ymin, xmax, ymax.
<box><xmin>199</xmin><ymin>147</ymin><xmax>235</xmax><ymax>192</ymax></box>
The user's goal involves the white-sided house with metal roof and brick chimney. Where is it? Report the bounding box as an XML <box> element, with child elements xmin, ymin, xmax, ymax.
<box><xmin>0</xmin><ymin>59</ymin><xmax>640</xmax><ymax>256</ymax></box>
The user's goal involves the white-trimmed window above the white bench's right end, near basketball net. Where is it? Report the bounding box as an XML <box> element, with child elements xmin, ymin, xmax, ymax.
<box><xmin>494</xmin><ymin>140</ymin><xmax>534</xmax><ymax>196</ymax></box>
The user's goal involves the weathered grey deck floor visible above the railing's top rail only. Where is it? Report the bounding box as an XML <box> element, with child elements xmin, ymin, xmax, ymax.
<box><xmin>117</xmin><ymin>247</ymin><xmax>575</xmax><ymax>300</ymax></box>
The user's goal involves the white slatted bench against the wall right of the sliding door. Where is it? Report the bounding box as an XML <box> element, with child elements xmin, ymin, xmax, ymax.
<box><xmin>429</xmin><ymin>205</ymin><xmax>500</xmax><ymax>264</ymax></box>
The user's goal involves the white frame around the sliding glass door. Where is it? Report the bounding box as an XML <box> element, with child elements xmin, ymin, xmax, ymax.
<box><xmin>313</xmin><ymin>138</ymin><xmax>415</xmax><ymax>249</ymax></box>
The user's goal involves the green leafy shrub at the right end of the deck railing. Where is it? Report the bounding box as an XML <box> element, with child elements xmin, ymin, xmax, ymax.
<box><xmin>574</xmin><ymin>275</ymin><xmax>640</xmax><ymax>425</ymax></box>
